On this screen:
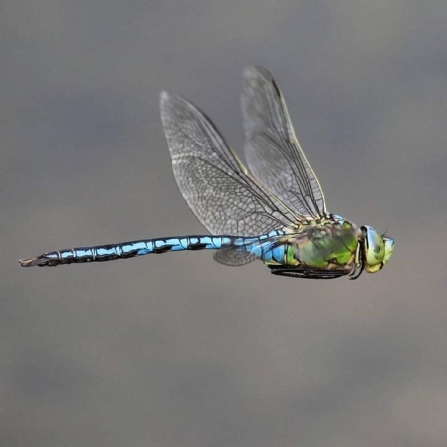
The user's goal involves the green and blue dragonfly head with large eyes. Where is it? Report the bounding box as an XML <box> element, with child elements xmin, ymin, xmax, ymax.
<box><xmin>361</xmin><ymin>225</ymin><xmax>394</xmax><ymax>273</ymax></box>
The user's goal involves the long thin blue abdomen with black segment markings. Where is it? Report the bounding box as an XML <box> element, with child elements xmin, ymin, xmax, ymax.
<box><xmin>20</xmin><ymin>236</ymin><xmax>258</xmax><ymax>267</ymax></box>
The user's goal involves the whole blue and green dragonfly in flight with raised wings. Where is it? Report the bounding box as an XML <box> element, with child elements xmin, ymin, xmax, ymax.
<box><xmin>19</xmin><ymin>66</ymin><xmax>394</xmax><ymax>279</ymax></box>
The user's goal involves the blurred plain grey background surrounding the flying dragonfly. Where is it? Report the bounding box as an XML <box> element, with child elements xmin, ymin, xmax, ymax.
<box><xmin>0</xmin><ymin>0</ymin><xmax>447</xmax><ymax>447</ymax></box>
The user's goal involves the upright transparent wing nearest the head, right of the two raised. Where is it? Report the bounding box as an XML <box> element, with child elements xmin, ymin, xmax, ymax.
<box><xmin>241</xmin><ymin>67</ymin><xmax>326</xmax><ymax>218</ymax></box>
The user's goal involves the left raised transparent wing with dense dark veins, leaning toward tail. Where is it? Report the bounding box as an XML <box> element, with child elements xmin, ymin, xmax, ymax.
<box><xmin>160</xmin><ymin>92</ymin><xmax>295</xmax><ymax>236</ymax></box>
